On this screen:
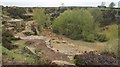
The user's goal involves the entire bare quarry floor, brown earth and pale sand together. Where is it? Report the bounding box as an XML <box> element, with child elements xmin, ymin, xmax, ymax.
<box><xmin>14</xmin><ymin>30</ymin><xmax>106</xmax><ymax>63</ymax></box>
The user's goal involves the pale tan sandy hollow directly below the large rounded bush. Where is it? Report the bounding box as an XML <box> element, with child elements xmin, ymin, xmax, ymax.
<box><xmin>42</xmin><ymin>30</ymin><xmax>103</xmax><ymax>55</ymax></box>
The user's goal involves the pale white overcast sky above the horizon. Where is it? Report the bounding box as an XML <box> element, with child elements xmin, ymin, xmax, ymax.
<box><xmin>0</xmin><ymin>0</ymin><xmax>120</xmax><ymax>7</ymax></box>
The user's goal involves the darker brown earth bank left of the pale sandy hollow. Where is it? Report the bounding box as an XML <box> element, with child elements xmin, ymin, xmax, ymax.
<box><xmin>26</xmin><ymin>39</ymin><xmax>69</xmax><ymax>61</ymax></box>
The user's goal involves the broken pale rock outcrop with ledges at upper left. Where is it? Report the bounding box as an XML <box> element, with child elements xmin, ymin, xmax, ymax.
<box><xmin>4</xmin><ymin>19</ymin><xmax>40</xmax><ymax>36</ymax></box>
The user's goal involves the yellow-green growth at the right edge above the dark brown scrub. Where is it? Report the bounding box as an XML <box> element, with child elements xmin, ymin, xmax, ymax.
<box><xmin>103</xmin><ymin>24</ymin><xmax>118</xmax><ymax>55</ymax></box>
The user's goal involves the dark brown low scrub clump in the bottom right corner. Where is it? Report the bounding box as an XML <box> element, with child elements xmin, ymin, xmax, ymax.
<box><xmin>74</xmin><ymin>51</ymin><xmax>118</xmax><ymax>65</ymax></box>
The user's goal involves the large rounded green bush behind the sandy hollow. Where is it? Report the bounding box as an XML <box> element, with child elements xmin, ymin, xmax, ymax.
<box><xmin>53</xmin><ymin>9</ymin><xmax>97</xmax><ymax>41</ymax></box>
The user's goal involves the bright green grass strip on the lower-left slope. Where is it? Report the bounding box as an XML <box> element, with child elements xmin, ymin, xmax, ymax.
<box><xmin>0</xmin><ymin>42</ymin><xmax>34</xmax><ymax>64</ymax></box>
